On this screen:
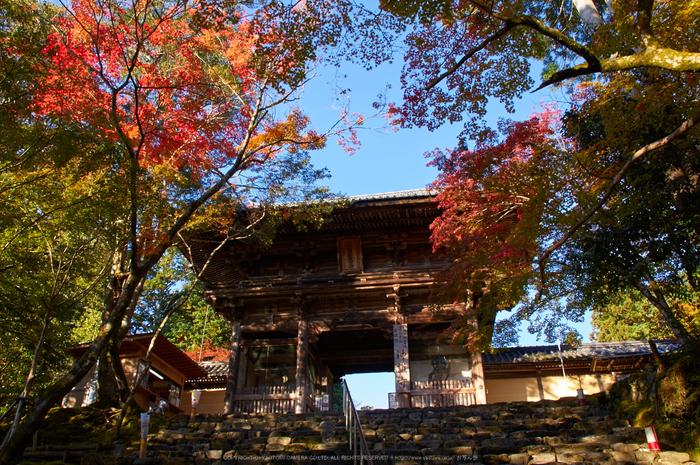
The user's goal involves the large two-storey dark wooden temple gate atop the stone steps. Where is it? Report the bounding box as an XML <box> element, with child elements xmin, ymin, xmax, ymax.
<box><xmin>186</xmin><ymin>190</ymin><xmax>485</xmax><ymax>413</ymax></box>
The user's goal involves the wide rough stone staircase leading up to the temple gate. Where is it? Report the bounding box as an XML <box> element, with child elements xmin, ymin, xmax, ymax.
<box><xmin>20</xmin><ymin>399</ymin><xmax>693</xmax><ymax>465</ymax></box>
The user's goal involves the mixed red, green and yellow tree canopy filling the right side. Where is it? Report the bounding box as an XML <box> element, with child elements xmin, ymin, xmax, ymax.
<box><xmin>382</xmin><ymin>0</ymin><xmax>700</xmax><ymax>346</ymax></box>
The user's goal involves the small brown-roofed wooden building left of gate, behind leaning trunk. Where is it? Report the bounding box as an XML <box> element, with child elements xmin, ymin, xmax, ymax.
<box><xmin>62</xmin><ymin>333</ymin><xmax>207</xmax><ymax>415</ymax></box>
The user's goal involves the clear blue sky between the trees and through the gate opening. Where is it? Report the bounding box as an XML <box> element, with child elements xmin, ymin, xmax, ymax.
<box><xmin>298</xmin><ymin>59</ymin><xmax>591</xmax><ymax>408</ymax></box>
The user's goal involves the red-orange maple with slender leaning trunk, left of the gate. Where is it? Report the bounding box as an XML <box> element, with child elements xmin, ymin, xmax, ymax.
<box><xmin>0</xmin><ymin>0</ymin><xmax>366</xmax><ymax>456</ymax></box>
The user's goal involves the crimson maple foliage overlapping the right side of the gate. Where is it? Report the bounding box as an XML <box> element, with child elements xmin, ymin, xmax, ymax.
<box><xmin>429</xmin><ymin>108</ymin><xmax>571</xmax><ymax>349</ymax></box>
